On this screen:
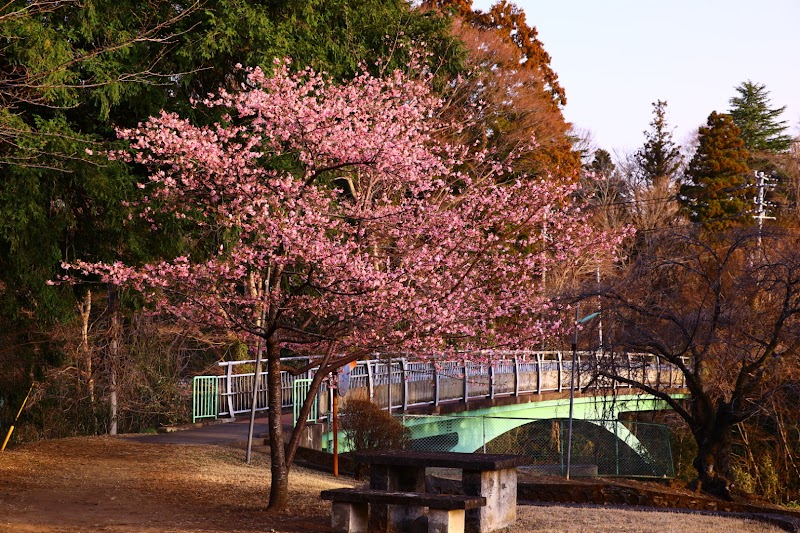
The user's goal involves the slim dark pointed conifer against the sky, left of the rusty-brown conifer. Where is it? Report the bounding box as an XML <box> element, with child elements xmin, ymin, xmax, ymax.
<box><xmin>634</xmin><ymin>100</ymin><xmax>683</xmax><ymax>185</ymax></box>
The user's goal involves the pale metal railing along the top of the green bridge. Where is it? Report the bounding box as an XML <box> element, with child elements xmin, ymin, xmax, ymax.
<box><xmin>193</xmin><ymin>351</ymin><xmax>685</xmax><ymax>420</ymax></box>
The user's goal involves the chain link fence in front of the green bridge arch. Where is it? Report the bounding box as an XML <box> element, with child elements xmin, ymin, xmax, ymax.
<box><xmin>398</xmin><ymin>415</ymin><xmax>675</xmax><ymax>478</ymax></box>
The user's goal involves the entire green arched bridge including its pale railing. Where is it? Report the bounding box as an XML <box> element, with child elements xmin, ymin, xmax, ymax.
<box><xmin>194</xmin><ymin>352</ymin><xmax>685</xmax><ymax>477</ymax></box>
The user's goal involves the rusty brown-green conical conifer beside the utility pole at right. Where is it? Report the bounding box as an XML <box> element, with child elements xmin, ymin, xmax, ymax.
<box><xmin>680</xmin><ymin>111</ymin><xmax>750</xmax><ymax>231</ymax></box>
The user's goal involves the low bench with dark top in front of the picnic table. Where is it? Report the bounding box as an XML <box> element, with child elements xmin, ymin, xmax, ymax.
<box><xmin>320</xmin><ymin>489</ymin><xmax>486</xmax><ymax>533</ymax></box>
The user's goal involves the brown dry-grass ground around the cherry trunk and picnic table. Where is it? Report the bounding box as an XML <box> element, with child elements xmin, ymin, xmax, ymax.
<box><xmin>0</xmin><ymin>437</ymin><xmax>781</xmax><ymax>533</ymax></box>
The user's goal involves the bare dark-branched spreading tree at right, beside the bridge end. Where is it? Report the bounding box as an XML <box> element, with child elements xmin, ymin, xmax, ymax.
<box><xmin>596</xmin><ymin>228</ymin><xmax>800</xmax><ymax>495</ymax></box>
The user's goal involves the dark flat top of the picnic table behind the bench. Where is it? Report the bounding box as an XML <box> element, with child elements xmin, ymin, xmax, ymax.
<box><xmin>347</xmin><ymin>450</ymin><xmax>528</xmax><ymax>471</ymax></box>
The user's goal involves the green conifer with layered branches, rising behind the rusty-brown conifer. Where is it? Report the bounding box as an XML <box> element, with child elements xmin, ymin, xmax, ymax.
<box><xmin>730</xmin><ymin>80</ymin><xmax>792</xmax><ymax>153</ymax></box>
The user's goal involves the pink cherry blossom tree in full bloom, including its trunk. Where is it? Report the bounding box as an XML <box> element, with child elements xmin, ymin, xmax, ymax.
<box><xmin>68</xmin><ymin>62</ymin><xmax>619</xmax><ymax>510</ymax></box>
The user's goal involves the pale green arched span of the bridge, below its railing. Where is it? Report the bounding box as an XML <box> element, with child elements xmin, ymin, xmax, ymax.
<box><xmin>322</xmin><ymin>391</ymin><xmax>686</xmax><ymax>478</ymax></box>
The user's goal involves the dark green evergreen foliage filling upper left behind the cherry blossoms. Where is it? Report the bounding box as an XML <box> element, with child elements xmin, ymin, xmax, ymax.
<box><xmin>0</xmin><ymin>0</ymin><xmax>462</xmax><ymax>434</ymax></box>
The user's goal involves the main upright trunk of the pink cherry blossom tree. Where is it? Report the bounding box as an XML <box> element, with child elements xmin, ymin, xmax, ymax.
<box><xmin>266</xmin><ymin>338</ymin><xmax>289</xmax><ymax>512</ymax></box>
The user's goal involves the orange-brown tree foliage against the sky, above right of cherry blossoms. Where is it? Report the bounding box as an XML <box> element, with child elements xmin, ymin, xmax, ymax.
<box><xmin>424</xmin><ymin>0</ymin><xmax>580</xmax><ymax>180</ymax></box>
